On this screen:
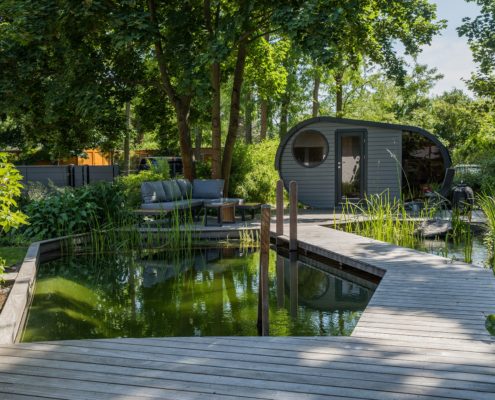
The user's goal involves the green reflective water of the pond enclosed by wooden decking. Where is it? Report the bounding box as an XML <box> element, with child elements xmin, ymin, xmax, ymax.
<box><xmin>22</xmin><ymin>248</ymin><xmax>376</xmax><ymax>342</ymax></box>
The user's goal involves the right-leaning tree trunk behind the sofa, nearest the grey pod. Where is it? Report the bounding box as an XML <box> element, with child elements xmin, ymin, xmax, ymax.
<box><xmin>222</xmin><ymin>40</ymin><xmax>247</xmax><ymax>196</ymax></box>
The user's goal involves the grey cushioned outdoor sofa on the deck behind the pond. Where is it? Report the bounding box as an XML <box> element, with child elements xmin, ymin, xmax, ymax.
<box><xmin>141</xmin><ymin>179</ymin><xmax>244</xmax><ymax>213</ymax></box>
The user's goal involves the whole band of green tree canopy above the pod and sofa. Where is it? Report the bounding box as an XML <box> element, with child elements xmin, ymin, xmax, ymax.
<box><xmin>0</xmin><ymin>0</ymin><xmax>494</xmax><ymax>193</ymax></box>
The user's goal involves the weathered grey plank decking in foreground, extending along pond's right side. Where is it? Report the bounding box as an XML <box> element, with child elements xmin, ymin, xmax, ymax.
<box><xmin>0</xmin><ymin>221</ymin><xmax>495</xmax><ymax>400</ymax></box>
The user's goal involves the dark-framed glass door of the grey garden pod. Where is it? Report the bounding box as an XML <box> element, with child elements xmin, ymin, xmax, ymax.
<box><xmin>335</xmin><ymin>130</ymin><xmax>366</xmax><ymax>204</ymax></box>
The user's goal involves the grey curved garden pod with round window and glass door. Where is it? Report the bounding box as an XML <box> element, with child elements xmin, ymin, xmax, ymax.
<box><xmin>275</xmin><ymin>117</ymin><xmax>451</xmax><ymax>208</ymax></box>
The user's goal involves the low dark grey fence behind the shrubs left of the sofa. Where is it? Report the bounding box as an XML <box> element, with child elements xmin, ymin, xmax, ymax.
<box><xmin>16</xmin><ymin>165</ymin><xmax>119</xmax><ymax>187</ymax></box>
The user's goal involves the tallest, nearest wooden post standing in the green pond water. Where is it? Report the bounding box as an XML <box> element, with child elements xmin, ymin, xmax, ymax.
<box><xmin>258</xmin><ymin>204</ymin><xmax>270</xmax><ymax>336</ymax></box>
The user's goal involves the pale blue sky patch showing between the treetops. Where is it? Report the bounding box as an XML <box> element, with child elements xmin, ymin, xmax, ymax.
<box><xmin>418</xmin><ymin>0</ymin><xmax>479</xmax><ymax>94</ymax></box>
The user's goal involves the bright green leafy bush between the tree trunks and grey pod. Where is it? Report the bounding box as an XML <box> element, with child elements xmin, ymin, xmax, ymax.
<box><xmin>231</xmin><ymin>140</ymin><xmax>279</xmax><ymax>203</ymax></box>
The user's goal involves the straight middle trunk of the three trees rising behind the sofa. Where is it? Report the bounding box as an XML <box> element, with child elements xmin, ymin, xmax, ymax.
<box><xmin>211</xmin><ymin>62</ymin><xmax>222</xmax><ymax>179</ymax></box>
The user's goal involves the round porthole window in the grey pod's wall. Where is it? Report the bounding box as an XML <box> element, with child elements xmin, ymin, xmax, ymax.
<box><xmin>292</xmin><ymin>131</ymin><xmax>328</xmax><ymax>168</ymax></box>
